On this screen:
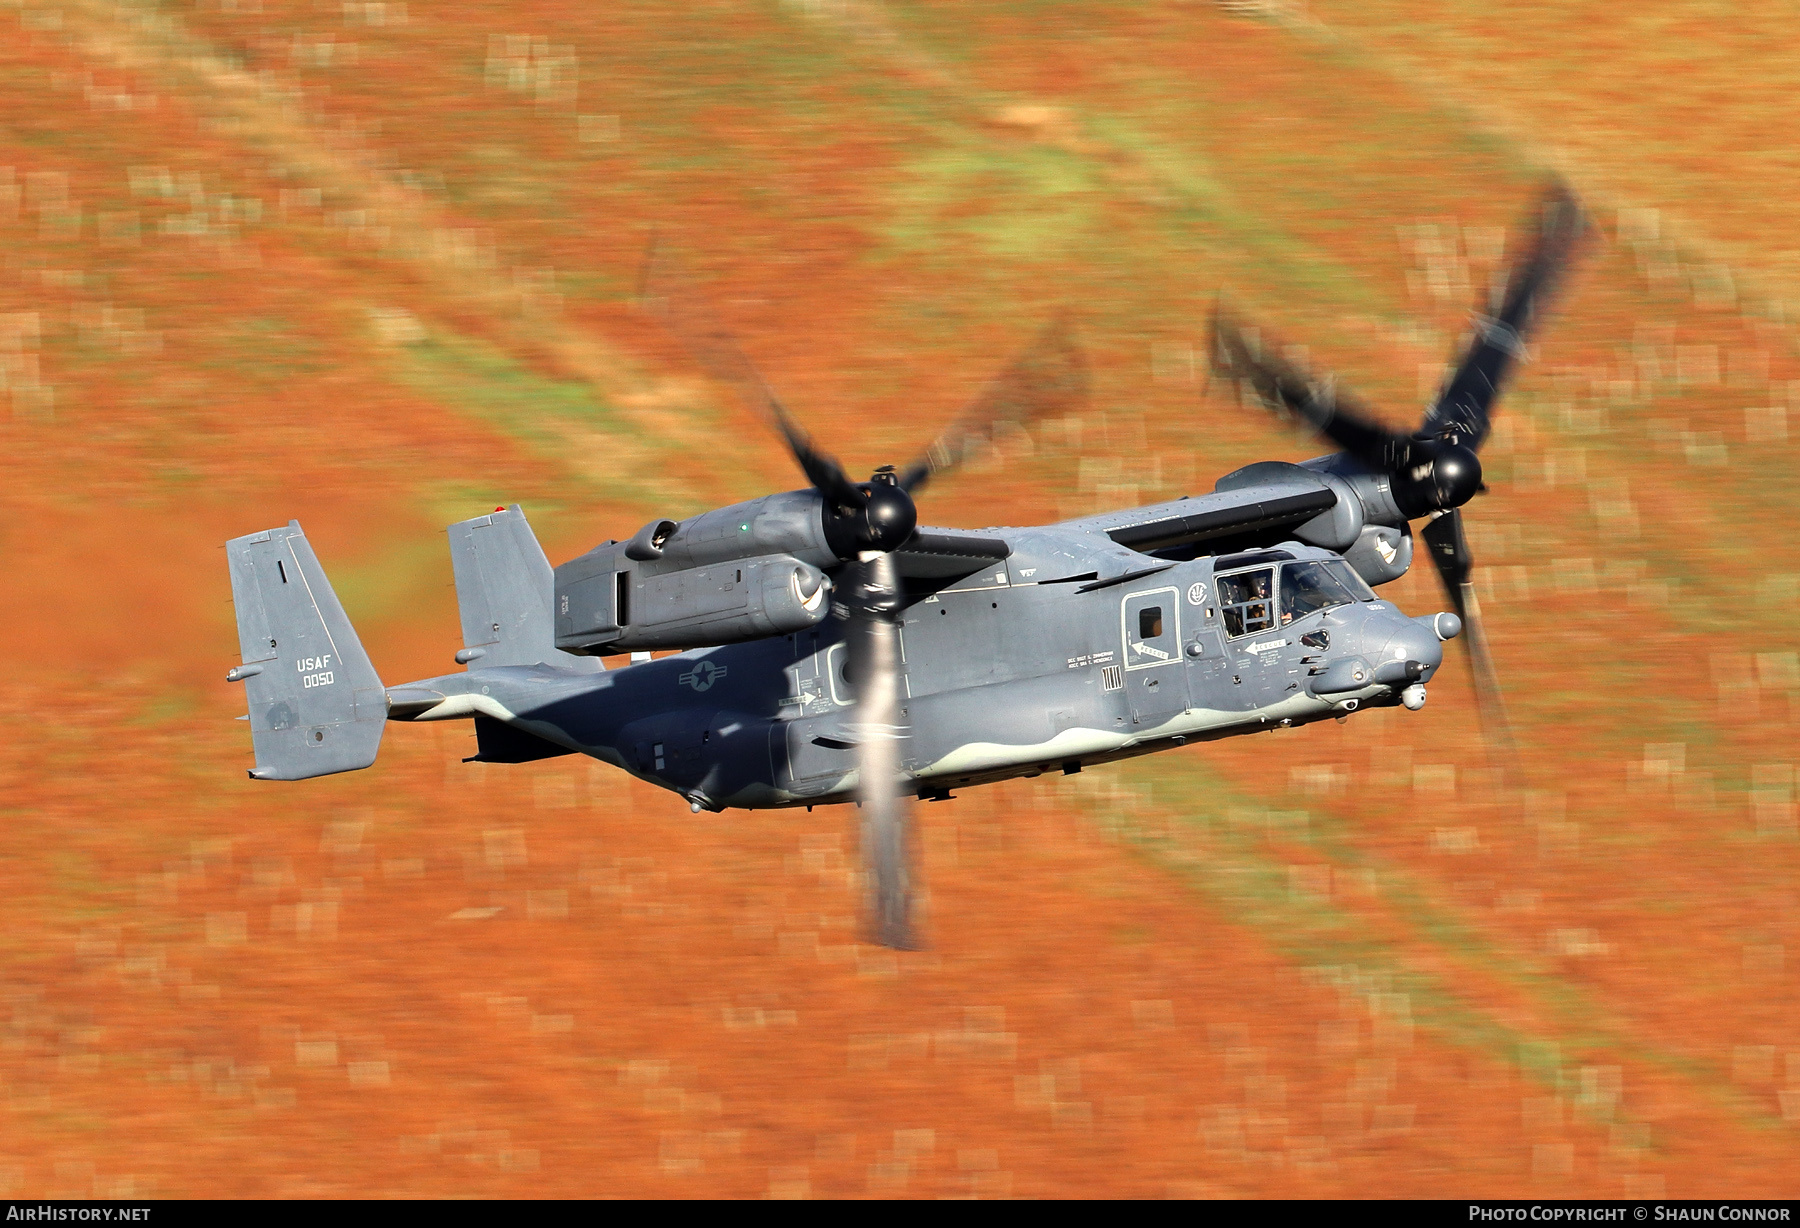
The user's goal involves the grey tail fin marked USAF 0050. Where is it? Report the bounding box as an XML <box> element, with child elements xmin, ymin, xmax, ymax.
<box><xmin>225</xmin><ymin>520</ymin><xmax>387</xmax><ymax>780</ymax></box>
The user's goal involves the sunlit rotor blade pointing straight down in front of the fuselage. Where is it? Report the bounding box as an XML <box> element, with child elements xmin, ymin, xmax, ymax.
<box><xmin>848</xmin><ymin>555</ymin><xmax>918</xmax><ymax>951</ymax></box>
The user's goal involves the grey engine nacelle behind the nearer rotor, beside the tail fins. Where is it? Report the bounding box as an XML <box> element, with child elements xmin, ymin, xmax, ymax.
<box><xmin>554</xmin><ymin>490</ymin><xmax>839</xmax><ymax>655</ymax></box>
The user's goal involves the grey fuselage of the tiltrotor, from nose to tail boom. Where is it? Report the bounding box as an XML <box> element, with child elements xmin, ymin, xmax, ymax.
<box><xmin>394</xmin><ymin>526</ymin><xmax>1454</xmax><ymax>810</ymax></box>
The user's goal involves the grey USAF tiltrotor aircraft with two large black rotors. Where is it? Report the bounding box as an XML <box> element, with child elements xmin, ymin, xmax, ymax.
<box><xmin>227</xmin><ymin>187</ymin><xmax>1584</xmax><ymax>947</ymax></box>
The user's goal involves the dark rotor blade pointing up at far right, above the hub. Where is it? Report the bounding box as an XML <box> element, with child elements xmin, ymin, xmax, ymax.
<box><xmin>1420</xmin><ymin>180</ymin><xmax>1588</xmax><ymax>450</ymax></box>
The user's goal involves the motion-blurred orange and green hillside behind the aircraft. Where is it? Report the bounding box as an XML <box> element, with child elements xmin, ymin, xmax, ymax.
<box><xmin>0</xmin><ymin>0</ymin><xmax>1800</xmax><ymax>1197</ymax></box>
